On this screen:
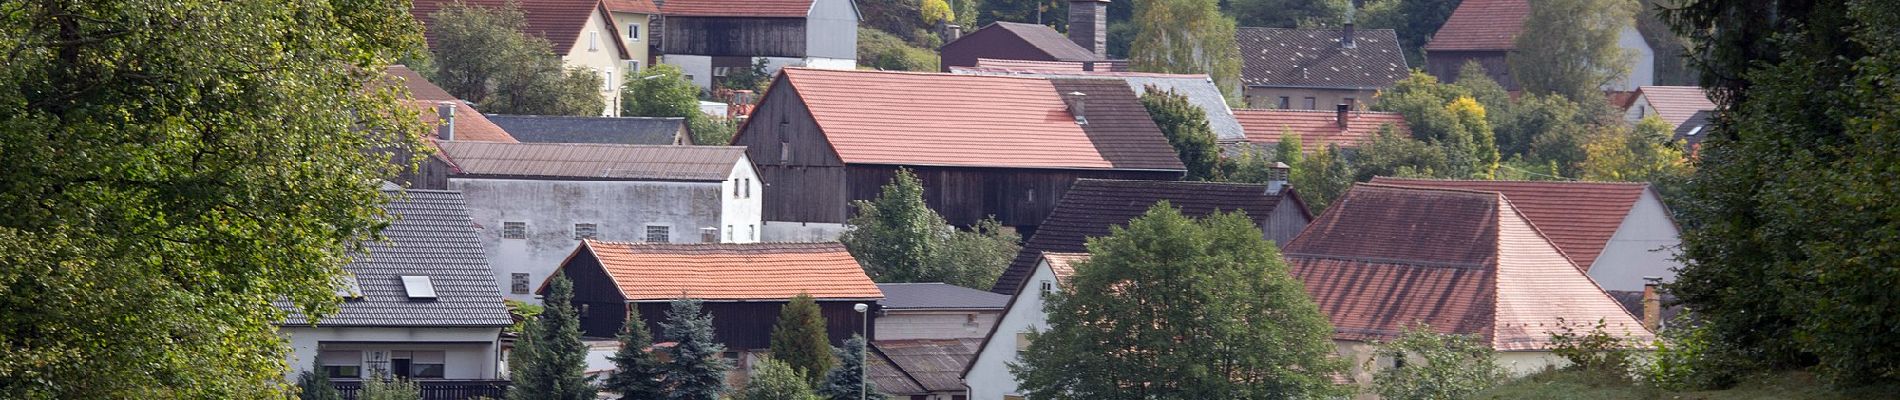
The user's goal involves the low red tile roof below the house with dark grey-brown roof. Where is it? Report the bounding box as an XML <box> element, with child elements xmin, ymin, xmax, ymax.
<box><xmin>1233</xmin><ymin>110</ymin><xmax>1412</xmax><ymax>152</ymax></box>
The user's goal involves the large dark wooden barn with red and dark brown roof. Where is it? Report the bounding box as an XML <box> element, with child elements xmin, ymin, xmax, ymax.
<box><xmin>733</xmin><ymin>68</ymin><xmax>1184</xmax><ymax>241</ymax></box>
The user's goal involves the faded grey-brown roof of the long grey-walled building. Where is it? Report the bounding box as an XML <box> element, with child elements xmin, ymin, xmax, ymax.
<box><xmin>439</xmin><ymin>140</ymin><xmax>745</xmax><ymax>182</ymax></box>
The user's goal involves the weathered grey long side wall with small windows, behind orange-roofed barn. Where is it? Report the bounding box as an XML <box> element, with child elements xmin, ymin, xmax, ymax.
<box><xmin>448</xmin><ymin>176</ymin><xmax>733</xmax><ymax>303</ymax></box>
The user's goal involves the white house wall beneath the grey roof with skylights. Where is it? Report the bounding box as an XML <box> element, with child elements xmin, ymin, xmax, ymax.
<box><xmin>277</xmin><ymin>326</ymin><xmax>502</xmax><ymax>379</ymax></box>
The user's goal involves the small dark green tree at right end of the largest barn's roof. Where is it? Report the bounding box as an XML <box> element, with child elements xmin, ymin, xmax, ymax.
<box><xmin>1140</xmin><ymin>85</ymin><xmax>1220</xmax><ymax>180</ymax></box>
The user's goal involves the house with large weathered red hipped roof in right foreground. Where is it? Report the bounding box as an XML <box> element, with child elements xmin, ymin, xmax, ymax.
<box><xmin>1284</xmin><ymin>184</ymin><xmax>1655</xmax><ymax>385</ymax></box>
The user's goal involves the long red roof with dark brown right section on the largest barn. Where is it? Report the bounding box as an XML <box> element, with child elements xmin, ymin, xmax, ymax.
<box><xmin>771</xmin><ymin>68</ymin><xmax>1182</xmax><ymax>171</ymax></box>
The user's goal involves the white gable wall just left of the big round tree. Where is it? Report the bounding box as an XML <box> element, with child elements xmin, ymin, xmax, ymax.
<box><xmin>957</xmin><ymin>264</ymin><xmax>1056</xmax><ymax>400</ymax></box>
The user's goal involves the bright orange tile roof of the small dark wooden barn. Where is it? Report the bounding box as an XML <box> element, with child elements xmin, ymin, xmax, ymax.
<box><xmin>562</xmin><ymin>241</ymin><xmax>884</xmax><ymax>301</ymax></box>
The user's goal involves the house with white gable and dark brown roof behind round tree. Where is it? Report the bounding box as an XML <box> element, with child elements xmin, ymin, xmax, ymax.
<box><xmin>961</xmin><ymin>180</ymin><xmax>1313</xmax><ymax>400</ymax></box>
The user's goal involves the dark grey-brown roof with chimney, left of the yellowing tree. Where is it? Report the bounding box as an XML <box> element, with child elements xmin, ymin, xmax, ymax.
<box><xmin>1235</xmin><ymin>28</ymin><xmax>1408</xmax><ymax>89</ymax></box>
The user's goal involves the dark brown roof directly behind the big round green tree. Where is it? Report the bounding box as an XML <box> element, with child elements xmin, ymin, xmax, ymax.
<box><xmin>990</xmin><ymin>178</ymin><xmax>1281</xmax><ymax>294</ymax></box>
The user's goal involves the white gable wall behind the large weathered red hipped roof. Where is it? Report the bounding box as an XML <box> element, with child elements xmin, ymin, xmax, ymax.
<box><xmin>1590</xmin><ymin>190</ymin><xmax>1682</xmax><ymax>290</ymax></box>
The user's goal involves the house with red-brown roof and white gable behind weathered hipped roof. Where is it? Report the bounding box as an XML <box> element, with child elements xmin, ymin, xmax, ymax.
<box><xmin>1372</xmin><ymin>176</ymin><xmax>1682</xmax><ymax>292</ymax></box>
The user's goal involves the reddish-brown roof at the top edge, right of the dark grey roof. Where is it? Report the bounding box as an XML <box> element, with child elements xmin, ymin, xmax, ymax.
<box><xmin>1425</xmin><ymin>0</ymin><xmax>1531</xmax><ymax>51</ymax></box>
